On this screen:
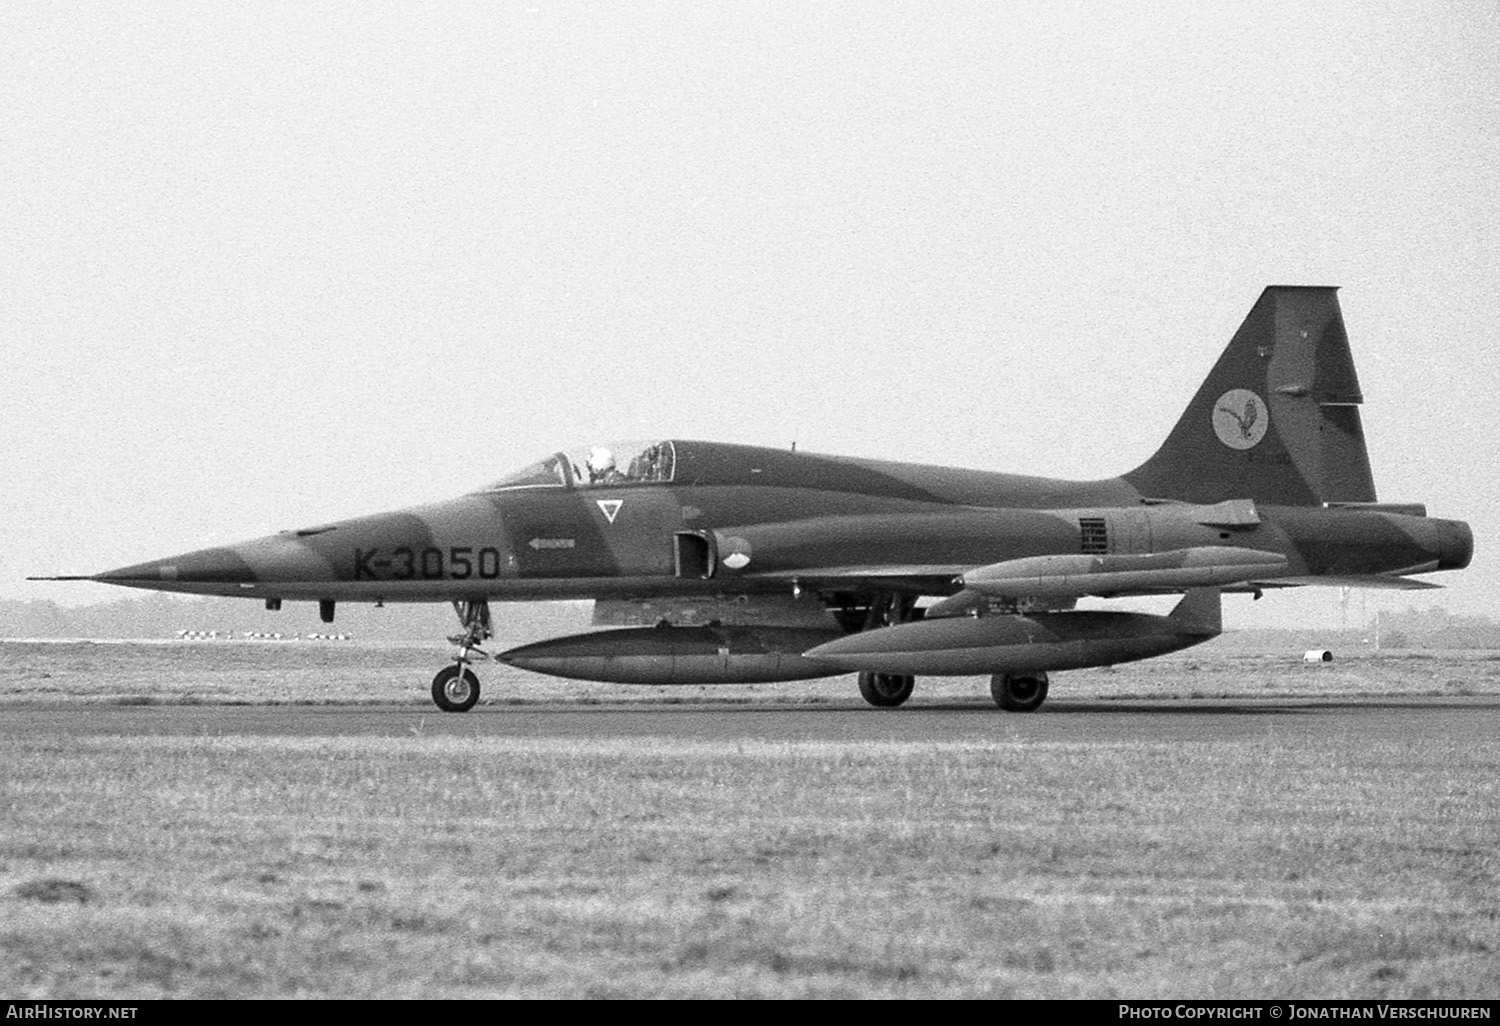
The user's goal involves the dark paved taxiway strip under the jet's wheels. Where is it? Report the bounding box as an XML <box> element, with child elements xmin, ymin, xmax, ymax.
<box><xmin>0</xmin><ymin>698</ymin><xmax>1500</xmax><ymax>744</ymax></box>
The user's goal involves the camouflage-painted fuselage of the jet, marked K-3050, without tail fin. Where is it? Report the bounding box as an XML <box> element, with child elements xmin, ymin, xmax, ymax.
<box><xmin>95</xmin><ymin>441</ymin><xmax>1473</xmax><ymax>602</ymax></box>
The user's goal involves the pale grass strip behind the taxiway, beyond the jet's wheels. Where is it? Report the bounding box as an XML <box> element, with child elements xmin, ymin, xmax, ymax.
<box><xmin>0</xmin><ymin>641</ymin><xmax>1500</xmax><ymax>708</ymax></box>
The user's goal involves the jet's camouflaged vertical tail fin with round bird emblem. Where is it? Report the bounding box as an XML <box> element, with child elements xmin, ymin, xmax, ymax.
<box><xmin>1125</xmin><ymin>285</ymin><xmax>1376</xmax><ymax>506</ymax></box>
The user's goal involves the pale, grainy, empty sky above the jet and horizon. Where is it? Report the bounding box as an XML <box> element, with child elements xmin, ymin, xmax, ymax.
<box><xmin>0</xmin><ymin>0</ymin><xmax>1500</xmax><ymax>626</ymax></box>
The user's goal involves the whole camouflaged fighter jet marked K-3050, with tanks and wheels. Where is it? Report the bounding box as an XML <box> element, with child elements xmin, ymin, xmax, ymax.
<box><xmin>32</xmin><ymin>285</ymin><xmax>1473</xmax><ymax>713</ymax></box>
